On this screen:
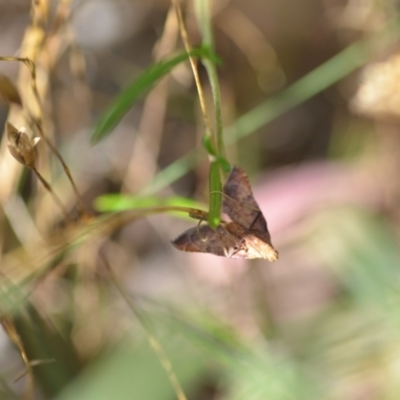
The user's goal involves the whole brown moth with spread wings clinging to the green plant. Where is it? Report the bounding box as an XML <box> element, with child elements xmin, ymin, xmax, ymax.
<box><xmin>172</xmin><ymin>166</ymin><xmax>278</xmax><ymax>261</ymax></box>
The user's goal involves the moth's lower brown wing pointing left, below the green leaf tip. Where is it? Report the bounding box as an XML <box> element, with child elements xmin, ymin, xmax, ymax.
<box><xmin>172</xmin><ymin>225</ymin><xmax>238</xmax><ymax>257</ymax></box>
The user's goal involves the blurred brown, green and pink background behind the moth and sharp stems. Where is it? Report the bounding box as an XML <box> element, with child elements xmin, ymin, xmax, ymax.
<box><xmin>0</xmin><ymin>0</ymin><xmax>400</xmax><ymax>400</ymax></box>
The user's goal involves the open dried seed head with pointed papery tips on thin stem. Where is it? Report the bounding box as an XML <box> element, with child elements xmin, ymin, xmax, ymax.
<box><xmin>7</xmin><ymin>122</ymin><xmax>37</xmax><ymax>168</ymax></box>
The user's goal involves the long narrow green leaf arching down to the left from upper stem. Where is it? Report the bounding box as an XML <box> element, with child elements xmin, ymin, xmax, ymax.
<box><xmin>92</xmin><ymin>47</ymin><xmax>216</xmax><ymax>143</ymax></box>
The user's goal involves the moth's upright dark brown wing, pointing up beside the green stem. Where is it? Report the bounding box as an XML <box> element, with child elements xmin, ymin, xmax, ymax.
<box><xmin>222</xmin><ymin>166</ymin><xmax>269</xmax><ymax>231</ymax></box>
